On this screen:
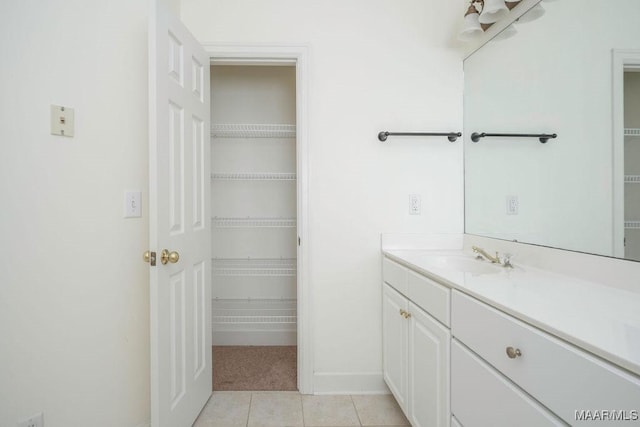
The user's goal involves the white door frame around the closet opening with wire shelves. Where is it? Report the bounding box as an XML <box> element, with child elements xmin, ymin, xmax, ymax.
<box><xmin>202</xmin><ymin>43</ymin><xmax>313</xmax><ymax>394</ymax></box>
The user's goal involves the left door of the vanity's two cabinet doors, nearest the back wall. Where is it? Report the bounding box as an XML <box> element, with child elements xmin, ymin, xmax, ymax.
<box><xmin>382</xmin><ymin>285</ymin><xmax>408</xmax><ymax>411</ymax></box>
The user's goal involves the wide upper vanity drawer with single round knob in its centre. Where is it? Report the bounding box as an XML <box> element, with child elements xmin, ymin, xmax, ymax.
<box><xmin>451</xmin><ymin>291</ymin><xmax>640</xmax><ymax>425</ymax></box>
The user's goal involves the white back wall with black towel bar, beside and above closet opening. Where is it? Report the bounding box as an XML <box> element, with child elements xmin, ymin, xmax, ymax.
<box><xmin>181</xmin><ymin>0</ymin><xmax>463</xmax><ymax>392</ymax></box>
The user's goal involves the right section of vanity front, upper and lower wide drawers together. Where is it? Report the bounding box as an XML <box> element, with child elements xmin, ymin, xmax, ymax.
<box><xmin>451</xmin><ymin>290</ymin><xmax>640</xmax><ymax>427</ymax></box>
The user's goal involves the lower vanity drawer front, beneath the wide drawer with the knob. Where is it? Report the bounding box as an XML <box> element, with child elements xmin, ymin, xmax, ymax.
<box><xmin>451</xmin><ymin>340</ymin><xmax>565</xmax><ymax>427</ymax></box>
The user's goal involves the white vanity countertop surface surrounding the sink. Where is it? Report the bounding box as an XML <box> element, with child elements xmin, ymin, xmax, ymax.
<box><xmin>383</xmin><ymin>249</ymin><xmax>640</xmax><ymax>375</ymax></box>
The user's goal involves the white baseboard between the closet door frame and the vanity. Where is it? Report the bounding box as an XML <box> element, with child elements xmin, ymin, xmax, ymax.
<box><xmin>313</xmin><ymin>372</ymin><xmax>391</xmax><ymax>394</ymax></box>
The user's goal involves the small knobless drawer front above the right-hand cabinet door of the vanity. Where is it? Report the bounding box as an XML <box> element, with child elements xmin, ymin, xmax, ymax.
<box><xmin>407</xmin><ymin>271</ymin><xmax>451</xmax><ymax>327</ymax></box>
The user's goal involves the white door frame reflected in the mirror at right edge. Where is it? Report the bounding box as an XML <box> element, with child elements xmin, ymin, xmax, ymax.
<box><xmin>611</xmin><ymin>49</ymin><xmax>640</xmax><ymax>258</ymax></box>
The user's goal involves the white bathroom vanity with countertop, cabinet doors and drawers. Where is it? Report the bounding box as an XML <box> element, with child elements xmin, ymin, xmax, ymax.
<box><xmin>382</xmin><ymin>236</ymin><xmax>640</xmax><ymax>427</ymax></box>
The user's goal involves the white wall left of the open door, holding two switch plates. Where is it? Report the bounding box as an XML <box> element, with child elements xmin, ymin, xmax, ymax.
<box><xmin>0</xmin><ymin>0</ymin><xmax>149</xmax><ymax>427</ymax></box>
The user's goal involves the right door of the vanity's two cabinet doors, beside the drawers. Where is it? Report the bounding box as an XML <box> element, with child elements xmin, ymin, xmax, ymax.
<box><xmin>408</xmin><ymin>303</ymin><xmax>451</xmax><ymax>427</ymax></box>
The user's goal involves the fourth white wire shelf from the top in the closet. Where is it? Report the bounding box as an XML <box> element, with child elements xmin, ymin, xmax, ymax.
<box><xmin>212</xmin><ymin>258</ymin><xmax>296</xmax><ymax>277</ymax></box>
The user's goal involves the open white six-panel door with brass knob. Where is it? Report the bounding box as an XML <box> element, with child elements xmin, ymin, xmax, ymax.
<box><xmin>149</xmin><ymin>1</ymin><xmax>212</xmax><ymax>427</ymax></box>
